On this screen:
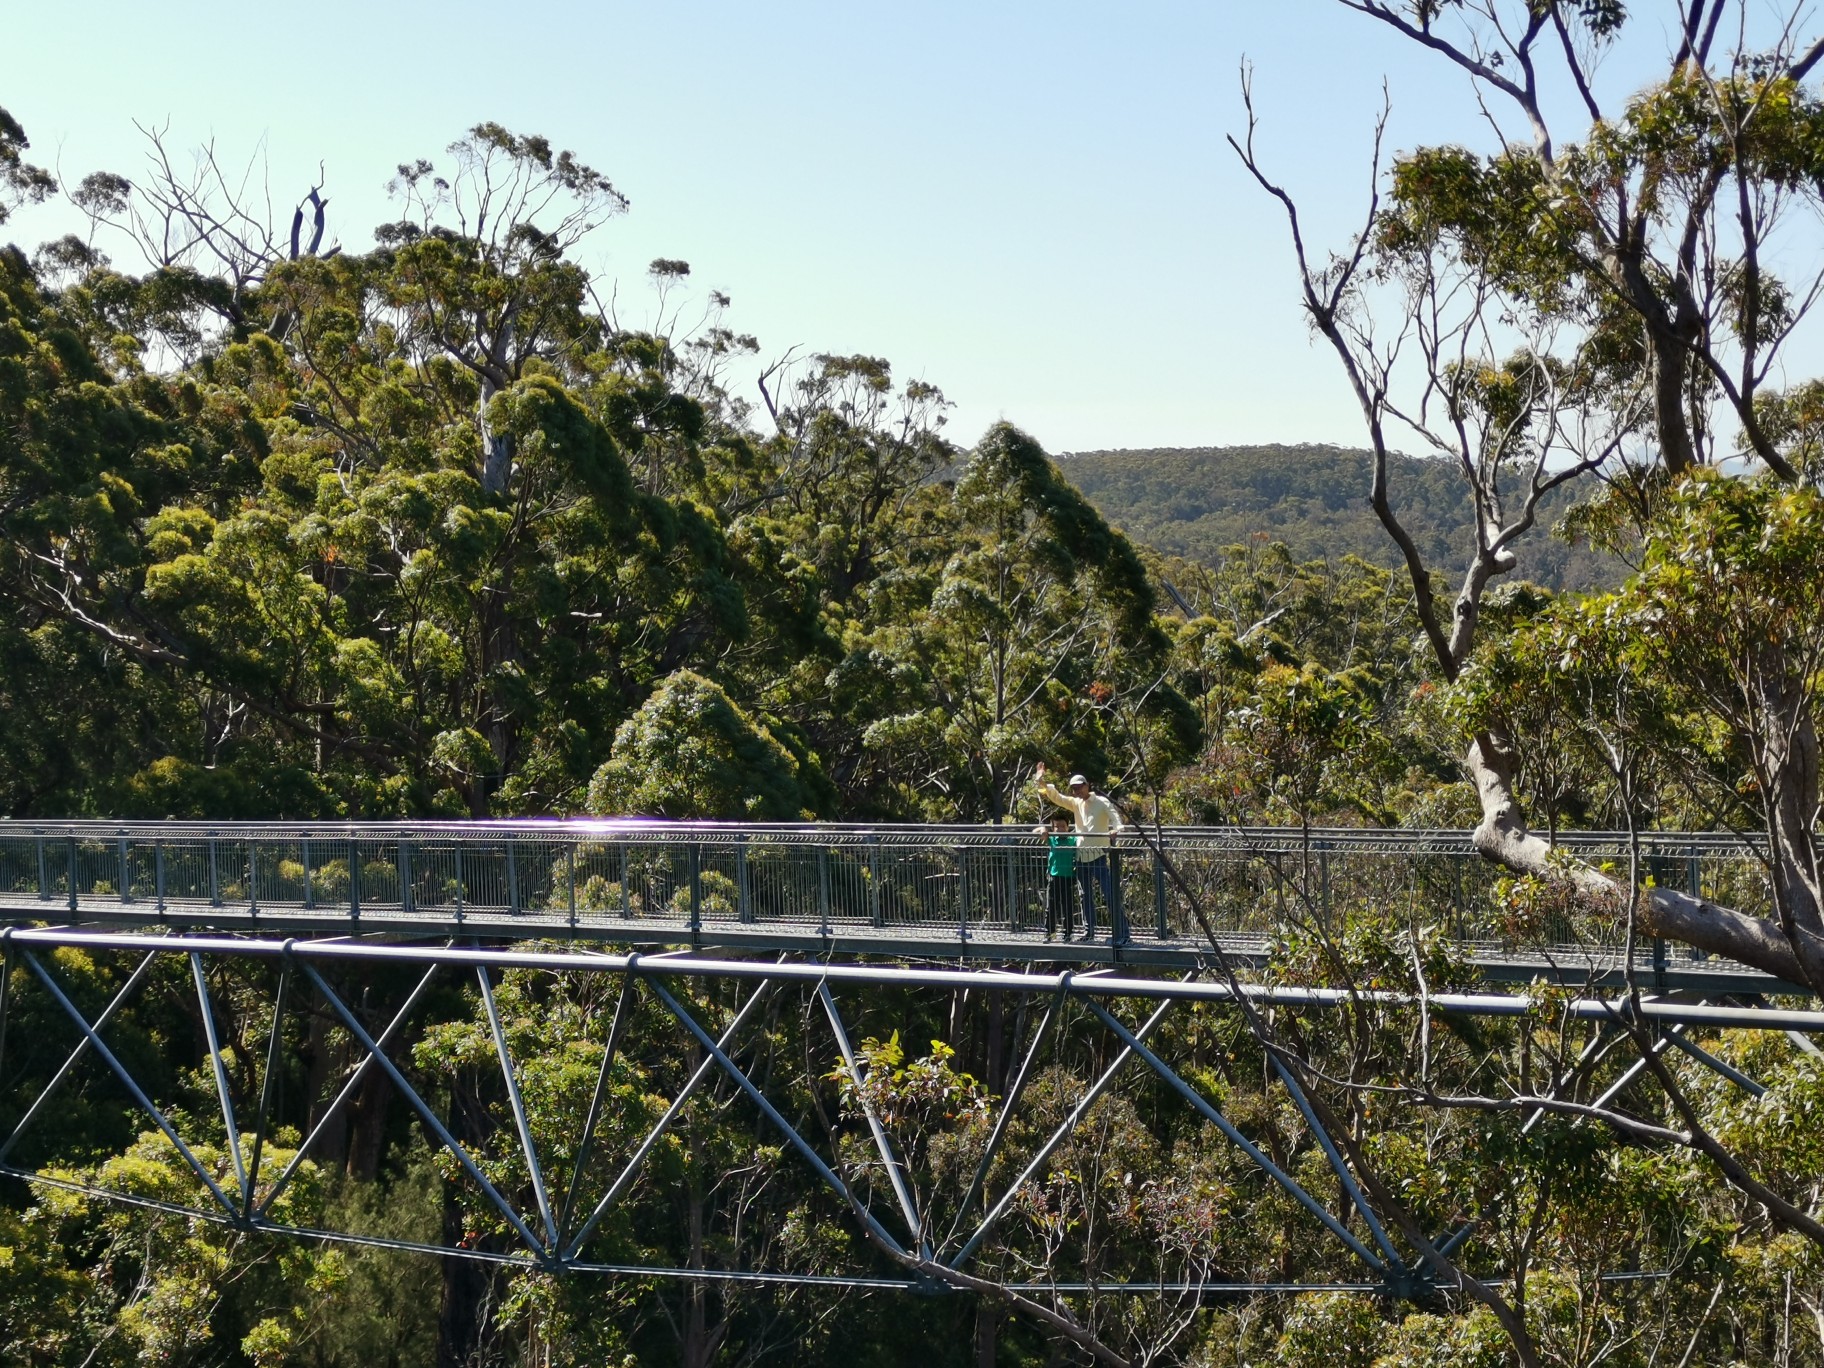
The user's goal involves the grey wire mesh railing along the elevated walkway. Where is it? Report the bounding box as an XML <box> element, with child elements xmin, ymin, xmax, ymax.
<box><xmin>0</xmin><ymin>821</ymin><xmax>1794</xmax><ymax>967</ymax></box>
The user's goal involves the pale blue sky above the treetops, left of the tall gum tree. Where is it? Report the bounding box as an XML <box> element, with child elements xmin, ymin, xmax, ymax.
<box><xmin>0</xmin><ymin>0</ymin><xmax>1707</xmax><ymax>451</ymax></box>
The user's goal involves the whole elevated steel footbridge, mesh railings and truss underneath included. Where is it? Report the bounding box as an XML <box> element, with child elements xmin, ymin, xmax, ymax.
<box><xmin>0</xmin><ymin>821</ymin><xmax>1824</xmax><ymax>1299</ymax></box>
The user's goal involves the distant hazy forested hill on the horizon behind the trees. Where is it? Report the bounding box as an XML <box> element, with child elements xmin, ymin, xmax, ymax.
<box><xmin>1060</xmin><ymin>445</ymin><xmax>1623</xmax><ymax>589</ymax></box>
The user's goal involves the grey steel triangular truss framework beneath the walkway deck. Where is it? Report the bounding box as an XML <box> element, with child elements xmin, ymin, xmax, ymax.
<box><xmin>0</xmin><ymin>928</ymin><xmax>1802</xmax><ymax>1295</ymax></box>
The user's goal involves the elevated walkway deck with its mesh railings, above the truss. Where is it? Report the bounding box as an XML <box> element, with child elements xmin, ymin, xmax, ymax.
<box><xmin>0</xmin><ymin>819</ymin><xmax>1800</xmax><ymax>994</ymax></box>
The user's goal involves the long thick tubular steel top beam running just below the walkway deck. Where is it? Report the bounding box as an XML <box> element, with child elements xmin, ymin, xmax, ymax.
<box><xmin>0</xmin><ymin>927</ymin><xmax>1824</xmax><ymax>1032</ymax></box>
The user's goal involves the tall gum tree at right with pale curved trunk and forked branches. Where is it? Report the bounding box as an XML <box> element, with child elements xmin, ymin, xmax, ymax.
<box><xmin>1231</xmin><ymin>0</ymin><xmax>1824</xmax><ymax>989</ymax></box>
